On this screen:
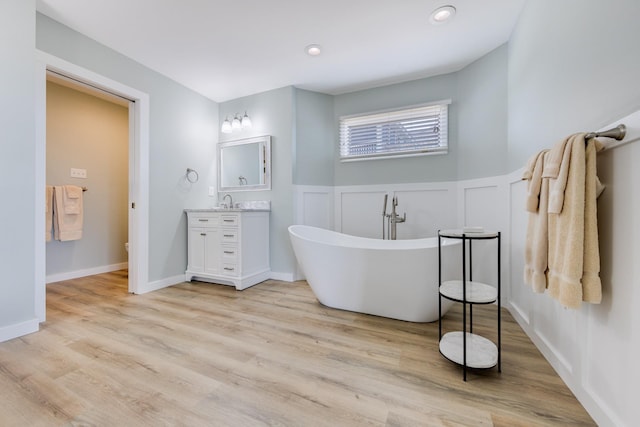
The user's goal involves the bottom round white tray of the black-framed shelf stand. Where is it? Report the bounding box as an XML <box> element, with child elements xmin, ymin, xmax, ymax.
<box><xmin>440</xmin><ymin>331</ymin><xmax>498</xmax><ymax>369</ymax></box>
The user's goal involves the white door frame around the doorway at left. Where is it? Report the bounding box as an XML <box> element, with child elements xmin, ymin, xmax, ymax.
<box><xmin>34</xmin><ymin>49</ymin><xmax>149</xmax><ymax>322</ymax></box>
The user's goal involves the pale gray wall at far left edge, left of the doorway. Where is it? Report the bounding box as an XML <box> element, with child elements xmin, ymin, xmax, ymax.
<box><xmin>0</xmin><ymin>0</ymin><xmax>36</xmax><ymax>329</ymax></box>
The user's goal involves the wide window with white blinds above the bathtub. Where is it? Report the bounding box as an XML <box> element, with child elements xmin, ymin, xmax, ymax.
<box><xmin>340</xmin><ymin>101</ymin><xmax>451</xmax><ymax>161</ymax></box>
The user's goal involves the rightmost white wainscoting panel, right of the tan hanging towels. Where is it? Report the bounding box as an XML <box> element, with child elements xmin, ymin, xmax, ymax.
<box><xmin>582</xmin><ymin>141</ymin><xmax>640</xmax><ymax>426</ymax></box>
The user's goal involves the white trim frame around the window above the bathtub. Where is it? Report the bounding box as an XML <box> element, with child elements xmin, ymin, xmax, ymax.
<box><xmin>339</xmin><ymin>99</ymin><xmax>451</xmax><ymax>162</ymax></box>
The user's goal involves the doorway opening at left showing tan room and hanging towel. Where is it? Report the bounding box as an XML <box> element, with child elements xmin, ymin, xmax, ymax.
<box><xmin>46</xmin><ymin>71</ymin><xmax>133</xmax><ymax>290</ymax></box>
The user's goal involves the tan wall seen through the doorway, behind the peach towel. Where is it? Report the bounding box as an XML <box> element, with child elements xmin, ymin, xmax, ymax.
<box><xmin>46</xmin><ymin>81</ymin><xmax>129</xmax><ymax>282</ymax></box>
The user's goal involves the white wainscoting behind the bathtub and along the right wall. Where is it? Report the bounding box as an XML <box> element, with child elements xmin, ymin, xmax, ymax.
<box><xmin>296</xmin><ymin>118</ymin><xmax>640</xmax><ymax>426</ymax></box>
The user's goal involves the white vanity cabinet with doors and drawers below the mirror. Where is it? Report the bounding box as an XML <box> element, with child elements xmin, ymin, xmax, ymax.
<box><xmin>185</xmin><ymin>209</ymin><xmax>271</xmax><ymax>290</ymax></box>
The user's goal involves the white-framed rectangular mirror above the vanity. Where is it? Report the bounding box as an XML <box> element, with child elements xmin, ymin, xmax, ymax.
<box><xmin>218</xmin><ymin>135</ymin><xmax>271</xmax><ymax>192</ymax></box>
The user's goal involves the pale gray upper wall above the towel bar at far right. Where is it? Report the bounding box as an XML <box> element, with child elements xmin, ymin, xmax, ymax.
<box><xmin>508</xmin><ymin>0</ymin><xmax>640</xmax><ymax>171</ymax></box>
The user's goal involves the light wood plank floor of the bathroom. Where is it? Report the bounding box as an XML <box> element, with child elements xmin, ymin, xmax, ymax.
<box><xmin>0</xmin><ymin>271</ymin><xmax>593</xmax><ymax>426</ymax></box>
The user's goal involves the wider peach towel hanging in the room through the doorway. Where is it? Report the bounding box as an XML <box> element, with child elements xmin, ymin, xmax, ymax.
<box><xmin>53</xmin><ymin>185</ymin><xmax>83</xmax><ymax>242</ymax></box>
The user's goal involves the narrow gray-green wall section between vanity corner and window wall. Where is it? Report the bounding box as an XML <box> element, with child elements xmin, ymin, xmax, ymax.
<box><xmin>293</xmin><ymin>89</ymin><xmax>337</xmax><ymax>186</ymax></box>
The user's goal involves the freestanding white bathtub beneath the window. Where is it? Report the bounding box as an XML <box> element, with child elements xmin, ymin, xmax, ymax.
<box><xmin>289</xmin><ymin>225</ymin><xmax>460</xmax><ymax>322</ymax></box>
